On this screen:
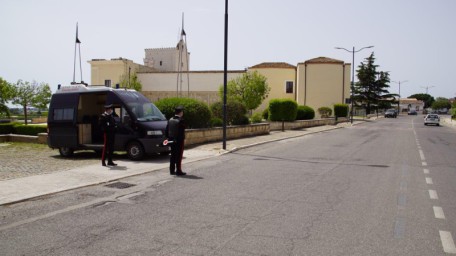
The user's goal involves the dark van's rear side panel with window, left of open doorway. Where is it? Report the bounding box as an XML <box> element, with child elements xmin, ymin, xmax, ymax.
<box><xmin>48</xmin><ymin>93</ymin><xmax>79</xmax><ymax>149</ymax></box>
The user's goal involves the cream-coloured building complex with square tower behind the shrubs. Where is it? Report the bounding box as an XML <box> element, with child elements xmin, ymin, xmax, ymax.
<box><xmin>89</xmin><ymin>40</ymin><xmax>351</xmax><ymax>117</ymax></box>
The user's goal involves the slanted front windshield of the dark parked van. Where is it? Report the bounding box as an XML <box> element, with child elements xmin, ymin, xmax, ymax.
<box><xmin>118</xmin><ymin>91</ymin><xmax>166</xmax><ymax>122</ymax></box>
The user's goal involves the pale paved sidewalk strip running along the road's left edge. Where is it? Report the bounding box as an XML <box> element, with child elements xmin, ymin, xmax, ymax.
<box><xmin>0</xmin><ymin>121</ymin><xmax>356</xmax><ymax>205</ymax></box>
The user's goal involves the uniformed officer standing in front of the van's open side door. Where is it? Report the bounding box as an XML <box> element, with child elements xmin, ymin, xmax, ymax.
<box><xmin>100</xmin><ymin>104</ymin><xmax>117</xmax><ymax>166</ymax></box>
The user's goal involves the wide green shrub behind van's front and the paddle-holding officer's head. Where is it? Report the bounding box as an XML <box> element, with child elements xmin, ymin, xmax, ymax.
<box><xmin>155</xmin><ymin>98</ymin><xmax>211</xmax><ymax>129</ymax></box>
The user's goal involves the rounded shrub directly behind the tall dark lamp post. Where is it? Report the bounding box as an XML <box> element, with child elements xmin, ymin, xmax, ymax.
<box><xmin>211</xmin><ymin>101</ymin><xmax>248</xmax><ymax>125</ymax></box>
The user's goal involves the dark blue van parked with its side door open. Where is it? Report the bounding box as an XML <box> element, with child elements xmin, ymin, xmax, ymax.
<box><xmin>48</xmin><ymin>84</ymin><xmax>170</xmax><ymax>160</ymax></box>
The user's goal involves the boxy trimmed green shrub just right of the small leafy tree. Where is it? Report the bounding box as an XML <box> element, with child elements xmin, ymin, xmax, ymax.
<box><xmin>269</xmin><ymin>99</ymin><xmax>298</xmax><ymax>122</ymax></box>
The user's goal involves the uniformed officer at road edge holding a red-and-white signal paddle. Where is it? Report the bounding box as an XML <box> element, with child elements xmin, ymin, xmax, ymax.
<box><xmin>166</xmin><ymin>106</ymin><xmax>187</xmax><ymax>176</ymax></box>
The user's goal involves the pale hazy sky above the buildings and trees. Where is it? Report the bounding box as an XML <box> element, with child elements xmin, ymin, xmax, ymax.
<box><xmin>0</xmin><ymin>0</ymin><xmax>456</xmax><ymax>102</ymax></box>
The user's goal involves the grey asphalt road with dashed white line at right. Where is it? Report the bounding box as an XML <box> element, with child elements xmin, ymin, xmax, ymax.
<box><xmin>0</xmin><ymin>116</ymin><xmax>456</xmax><ymax>255</ymax></box>
